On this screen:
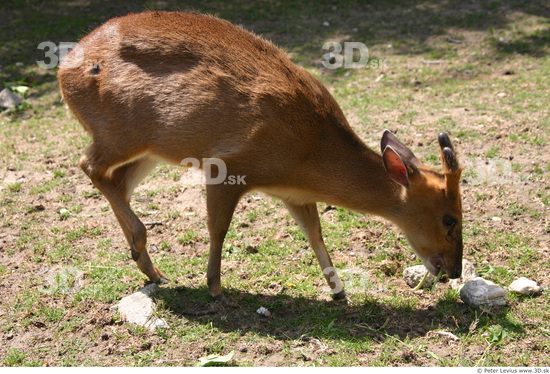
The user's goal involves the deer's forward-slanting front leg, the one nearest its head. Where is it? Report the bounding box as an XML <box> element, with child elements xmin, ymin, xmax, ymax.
<box><xmin>285</xmin><ymin>202</ymin><xmax>346</xmax><ymax>300</ymax></box>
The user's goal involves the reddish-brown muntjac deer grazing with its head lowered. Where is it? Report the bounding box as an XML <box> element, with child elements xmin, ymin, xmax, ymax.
<box><xmin>58</xmin><ymin>12</ymin><xmax>462</xmax><ymax>300</ymax></box>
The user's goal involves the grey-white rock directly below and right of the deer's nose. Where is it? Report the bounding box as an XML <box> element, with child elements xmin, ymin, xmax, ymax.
<box><xmin>460</xmin><ymin>277</ymin><xmax>506</xmax><ymax>307</ymax></box>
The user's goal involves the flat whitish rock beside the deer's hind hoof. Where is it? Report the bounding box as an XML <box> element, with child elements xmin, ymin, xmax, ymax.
<box><xmin>118</xmin><ymin>283</ymin><xmax>169</xmax><ymax>330</ymax></box>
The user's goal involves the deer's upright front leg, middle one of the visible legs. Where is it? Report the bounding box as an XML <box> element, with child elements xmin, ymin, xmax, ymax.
<box><xmin>206</xmin><ymin>184</ymin><xmax>244</xmax><ymax>301</ymax></box>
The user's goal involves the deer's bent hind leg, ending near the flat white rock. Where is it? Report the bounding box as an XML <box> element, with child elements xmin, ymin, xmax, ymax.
<box><xmin>79</xmin><ymin>143</ymin><xmax>168</xmax><ymax>283</ymax></box>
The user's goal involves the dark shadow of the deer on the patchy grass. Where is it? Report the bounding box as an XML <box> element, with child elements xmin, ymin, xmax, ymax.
<box><xmin>151</xmin><ymin>287</ymin><xmax>523</xmax><ymax>341</ymax></box>
